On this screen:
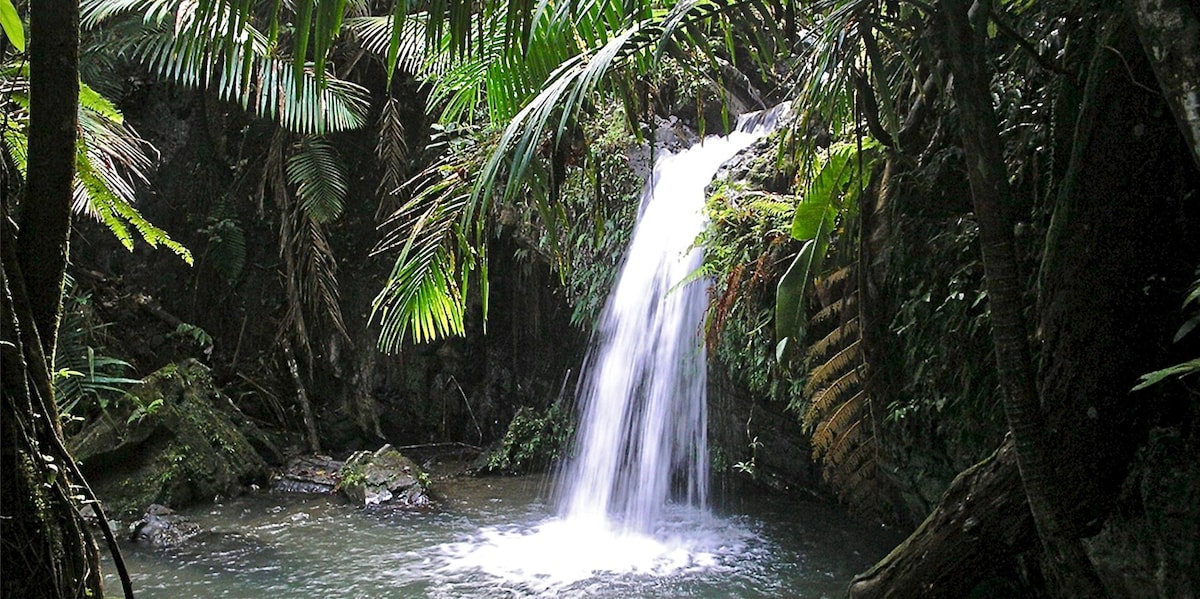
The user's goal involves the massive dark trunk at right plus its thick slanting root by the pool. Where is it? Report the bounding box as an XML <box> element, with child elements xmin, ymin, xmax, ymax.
<box><xmin>850</xmin><ymin>9</ymin><xmax>1200</xmax><ymax>598</ymax></box>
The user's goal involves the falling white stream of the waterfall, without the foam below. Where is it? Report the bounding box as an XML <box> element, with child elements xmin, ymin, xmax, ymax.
<box><xmin>559</xmin><ymin>107</ymin><xmax>786</xmax><ymax>533</ymax></box>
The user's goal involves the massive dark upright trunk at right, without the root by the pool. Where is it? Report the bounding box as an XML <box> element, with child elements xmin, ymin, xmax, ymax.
<box><xmin>1038</xmin><ymin>15</ymin><xmax>1200</xmax><ymax>549</ymax></box>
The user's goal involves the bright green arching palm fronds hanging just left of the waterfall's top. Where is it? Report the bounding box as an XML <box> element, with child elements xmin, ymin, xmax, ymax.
<box><xmin>364</xmin><ymin>0</ymin><xmax>796</xmax><ymax>348</ymax></box>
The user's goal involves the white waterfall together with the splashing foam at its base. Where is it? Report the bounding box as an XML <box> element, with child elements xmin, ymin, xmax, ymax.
<box><xmin>438</xmin><ymin>114</ymin><xmax>775</xmax><ymax>594</ymax></box>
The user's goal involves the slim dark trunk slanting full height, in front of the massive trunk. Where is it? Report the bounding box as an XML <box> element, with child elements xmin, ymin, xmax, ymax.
<box><xmin>942</xmin><ymin>0</ymin><xmax>1105</xmax><ymax>597</ymax></box>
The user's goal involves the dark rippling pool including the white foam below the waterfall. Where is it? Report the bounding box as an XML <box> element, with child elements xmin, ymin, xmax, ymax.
<box><xmin>106</xmin><ymin>478</ymin><xmax>898</xmax><ymax>599</ymax></box>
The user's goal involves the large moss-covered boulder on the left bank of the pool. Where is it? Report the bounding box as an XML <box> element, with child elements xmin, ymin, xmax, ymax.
<box><xmin>70</xmin><ymin>360</ymin><xmax>268</xmax><ymax>517</ymax></box>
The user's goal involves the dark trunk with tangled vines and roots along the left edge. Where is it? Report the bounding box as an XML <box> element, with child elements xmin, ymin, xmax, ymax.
<box><xmin>0</xmin><ymin>0</ymin><xmax>111</xmax><ymax>598</ymax></box>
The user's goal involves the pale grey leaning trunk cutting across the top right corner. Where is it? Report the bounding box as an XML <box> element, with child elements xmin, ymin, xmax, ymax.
<box><xmin>1127</xmin><ymin>0</ymin><xmax>1200</xmax><ymax>167</ymax></box>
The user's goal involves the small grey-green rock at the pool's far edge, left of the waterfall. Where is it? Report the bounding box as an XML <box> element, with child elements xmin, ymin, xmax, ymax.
<box><xmin>337</xmin><ymin>445</ymin><xmax>431</xmax><ymax>508</ymax></box>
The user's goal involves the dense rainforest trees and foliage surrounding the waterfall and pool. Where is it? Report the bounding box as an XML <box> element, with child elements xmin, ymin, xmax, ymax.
<box><xmin>0</xmin><ymin>0</ymin><xmax>1200</xmax><ymax>598</ymax></box>
